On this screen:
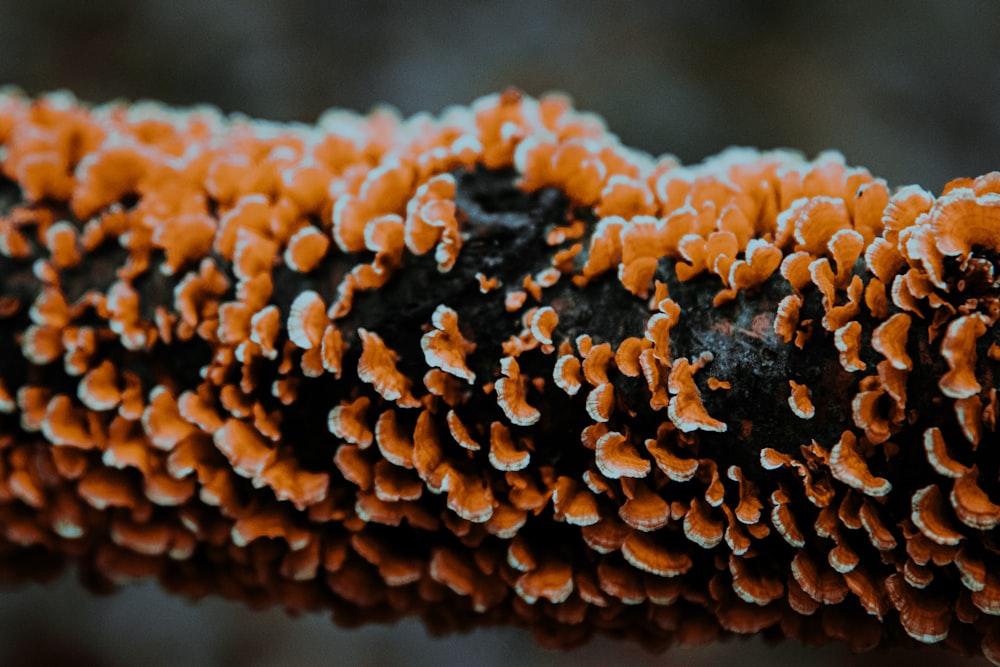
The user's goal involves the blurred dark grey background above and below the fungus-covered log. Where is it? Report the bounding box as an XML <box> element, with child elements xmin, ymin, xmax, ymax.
<box><xmin>0</xmin><ymin>0</ymin><xmax>1000</xmax><ymax>667</ymax></box>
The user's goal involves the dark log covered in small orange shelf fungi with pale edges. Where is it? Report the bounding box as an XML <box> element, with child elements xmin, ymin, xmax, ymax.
<box><xmin>0</xmin><ymin>91</ymin><xmax>1000</xmax><ymax>661</ymax></box>
